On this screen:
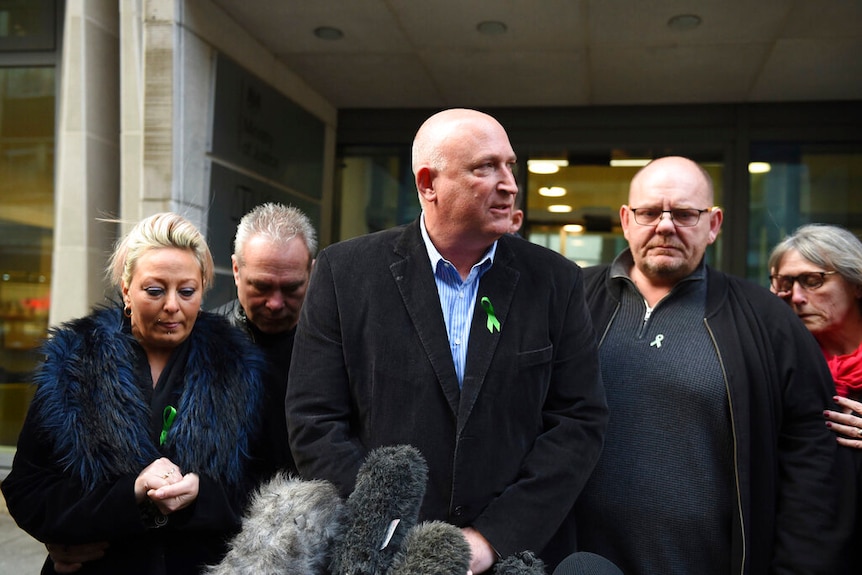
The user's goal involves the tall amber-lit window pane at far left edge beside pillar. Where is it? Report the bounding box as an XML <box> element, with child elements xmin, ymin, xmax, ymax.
<box><xmin>0</xmin><ymin>68</ymin><xmax>55</xmax><ymax>445</ymax></box>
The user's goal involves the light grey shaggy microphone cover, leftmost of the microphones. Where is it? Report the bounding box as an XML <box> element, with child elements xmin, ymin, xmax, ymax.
<box><xmin>205</xmin><ymin>474</ymin><xmax>346</xmax><ymax>575</ymax></box>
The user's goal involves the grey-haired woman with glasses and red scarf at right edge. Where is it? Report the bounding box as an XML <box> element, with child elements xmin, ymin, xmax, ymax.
<box><xmin>769</xmin><ymin>224</ymin><xmax>862</xmax><ymax>449</ymax></box>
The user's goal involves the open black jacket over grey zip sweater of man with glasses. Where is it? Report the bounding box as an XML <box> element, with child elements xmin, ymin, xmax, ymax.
<box><xmin>579</xmin><ymin>266</ymin><xmax>853</xmax><ymax>575</ymax></box>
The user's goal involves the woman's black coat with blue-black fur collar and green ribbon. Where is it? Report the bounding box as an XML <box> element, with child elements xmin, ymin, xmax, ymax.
<box><xmin>2</xmin><ymin>308</ymin><xmax>263</xmax><ymax>575</ymax></box>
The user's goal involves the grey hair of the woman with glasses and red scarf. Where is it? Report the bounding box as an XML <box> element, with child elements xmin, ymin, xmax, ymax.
<box><xmin>768</xmin><ymin>224</ymin><xmax>862</xmax><ymax>292</ymax></box>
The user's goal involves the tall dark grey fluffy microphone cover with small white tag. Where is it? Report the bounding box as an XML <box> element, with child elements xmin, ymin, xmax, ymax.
<box><xmin>331</xmin><ymin>445</ymin><xmax>428</xmax><ymax>575</ymax></box>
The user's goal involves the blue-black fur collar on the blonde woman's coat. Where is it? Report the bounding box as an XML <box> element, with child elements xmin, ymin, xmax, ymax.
<box><xmin>30</xmin><ymin>309</ymin><xmax>263</xmax><ymax>486</ymax></box>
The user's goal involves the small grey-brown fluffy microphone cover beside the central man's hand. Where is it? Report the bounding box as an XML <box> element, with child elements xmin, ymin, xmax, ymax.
<box><xmin>386</xmin><ymin>521</ymin><xmax>470</xmax><ymax>575</ymax></box>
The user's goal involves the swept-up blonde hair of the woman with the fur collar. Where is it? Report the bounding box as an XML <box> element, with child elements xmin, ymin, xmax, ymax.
<box><xmin>107</xmin><ymin>212</ymin><xmax>214</xmax><ymax>293</ymax></box>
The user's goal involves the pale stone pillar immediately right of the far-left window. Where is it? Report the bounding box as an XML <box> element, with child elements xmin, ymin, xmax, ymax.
<box><xmin>50</xmin><ymin>0</ymin><xmax>120</xmax><ymax>324</ymax></box>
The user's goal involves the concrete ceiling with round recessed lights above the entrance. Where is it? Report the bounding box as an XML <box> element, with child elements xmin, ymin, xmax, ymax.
<box><xmin>209</xmin><ymin>0</ymin><xmax>862</xmax><ymax>108</ymax></box>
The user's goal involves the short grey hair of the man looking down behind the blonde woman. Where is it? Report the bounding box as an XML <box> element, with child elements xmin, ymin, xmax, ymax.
<box><xmin>233</xmin><ymin>202</ymin><xmax>317</xmax><ymax>265</ymax></box>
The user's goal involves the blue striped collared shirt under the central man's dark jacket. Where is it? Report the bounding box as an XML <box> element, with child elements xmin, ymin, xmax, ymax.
<box><xmin>419</xmin><ymin>214</ymin><xmax>497</xmax><ymax>385</ymax></box>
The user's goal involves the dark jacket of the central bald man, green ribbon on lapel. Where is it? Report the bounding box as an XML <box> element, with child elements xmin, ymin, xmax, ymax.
<box><xmin>287</xmin><ymin>220</ymin><xmax>607</xmax><ymax>565</ymax></box>
